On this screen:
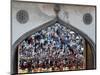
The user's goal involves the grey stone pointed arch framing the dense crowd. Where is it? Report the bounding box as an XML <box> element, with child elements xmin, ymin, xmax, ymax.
<box><xmin>11</xmin><ymin>18</ymin><xmax>96</xmax><ymax>74</ymax></box>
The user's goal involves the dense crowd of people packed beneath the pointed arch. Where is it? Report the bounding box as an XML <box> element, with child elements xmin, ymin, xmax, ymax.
<box><xmin>18</xmin><ymin>23</ymin><xmax>85</xmax><ymax>73</ymax></box>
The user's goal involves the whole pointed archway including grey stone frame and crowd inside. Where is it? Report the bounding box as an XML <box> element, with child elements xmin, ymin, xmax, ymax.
<box><xmin>12</xmin><ymin>18</ymin><xmax>95</xmax><ymax>73</ymax></box>
